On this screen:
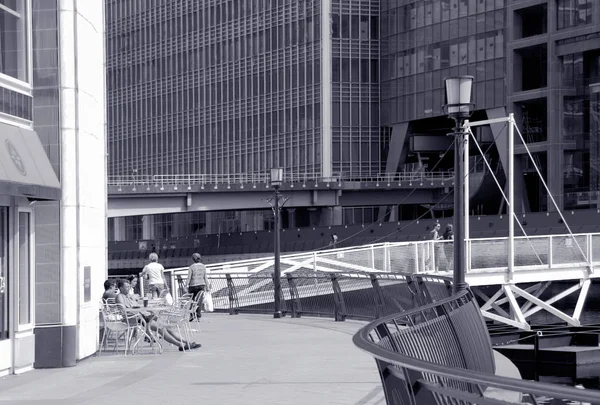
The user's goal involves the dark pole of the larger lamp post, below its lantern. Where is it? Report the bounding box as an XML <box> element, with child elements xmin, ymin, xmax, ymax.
<box><xmin>452</xmin><ymin>119</ymin><xmax>467</xmax><ymax>293</ymax></box>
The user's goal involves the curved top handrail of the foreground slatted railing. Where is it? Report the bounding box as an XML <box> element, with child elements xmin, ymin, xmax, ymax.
<box><xmin>352</xmin><ymin>290</ymin><xmax>600</xmax><ymax>404</ymax></box>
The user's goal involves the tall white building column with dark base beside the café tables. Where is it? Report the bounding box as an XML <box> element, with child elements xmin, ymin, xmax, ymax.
<box><xmin>48</xmin><ymin>0</ymin><xmax>108</xmax><ymax>367</ymax></box>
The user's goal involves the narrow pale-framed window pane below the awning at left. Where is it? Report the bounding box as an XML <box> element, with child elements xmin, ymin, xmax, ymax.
<box><xmin>18</xmin><ymin>212</ymin><xmax>31</xmax><ymax>325</ymax></box>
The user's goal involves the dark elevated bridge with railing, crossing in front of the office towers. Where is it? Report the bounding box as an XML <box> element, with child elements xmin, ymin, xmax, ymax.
<box><xmin>107</xmin><ymin>172</ymin><xmax>454</xmax><ymax>218</ymax></box>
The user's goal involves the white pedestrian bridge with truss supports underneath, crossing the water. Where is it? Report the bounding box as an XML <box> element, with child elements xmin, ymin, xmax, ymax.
<box><xmin>134</xmin><ymin>229</ymin><xmax>600</xmax><ymax>329</ymax></box>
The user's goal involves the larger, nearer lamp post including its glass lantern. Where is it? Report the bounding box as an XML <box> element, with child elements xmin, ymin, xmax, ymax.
<box><xmin>444</xmin><ymin>76</ymin><xmax>475</xmax><ymax>293</ymax></box>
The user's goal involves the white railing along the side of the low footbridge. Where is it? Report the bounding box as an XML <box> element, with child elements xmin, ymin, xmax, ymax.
<box><xmin>161</xmin><ymin>234</ymin><xmax>600</xmax><ymax>281</ymax></box>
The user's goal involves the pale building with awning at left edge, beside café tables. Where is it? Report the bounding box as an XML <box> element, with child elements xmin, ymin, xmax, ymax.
<box><xmin>0</xmin><ymin>0</ymin><xmax>106</xmax><ymax>375</ymax></box>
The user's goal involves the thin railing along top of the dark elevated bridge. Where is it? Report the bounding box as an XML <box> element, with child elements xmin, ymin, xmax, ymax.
<box><xmin>107</xmin><ymin>171</ymin><xmax>454</xmax><ymax>186</ymax></box>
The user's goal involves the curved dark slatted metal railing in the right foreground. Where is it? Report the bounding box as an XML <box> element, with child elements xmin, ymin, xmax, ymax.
<box><xmin>353</xmin><ymin>290</ymin><xmax>600</xmax><ymax>405</ymax></box>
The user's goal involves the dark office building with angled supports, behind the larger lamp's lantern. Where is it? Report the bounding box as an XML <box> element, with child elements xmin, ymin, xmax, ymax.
<box><xmin>381</xmin><ymin>0</ymin><xmax>600</xmax><ymax>212</ymax></box>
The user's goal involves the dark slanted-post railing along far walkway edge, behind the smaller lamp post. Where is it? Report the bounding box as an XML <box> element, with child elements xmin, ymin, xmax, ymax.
<box><xmin>129</xmin><ymin>270</ymin><xmax>451</xmax><ymax>321</ymax></box>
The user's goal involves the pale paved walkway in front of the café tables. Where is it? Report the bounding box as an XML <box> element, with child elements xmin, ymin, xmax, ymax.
<box><xmin>0</xmin><ymin>313</ymin><xmax>385</xmax><ymax>405</ymax></box>
